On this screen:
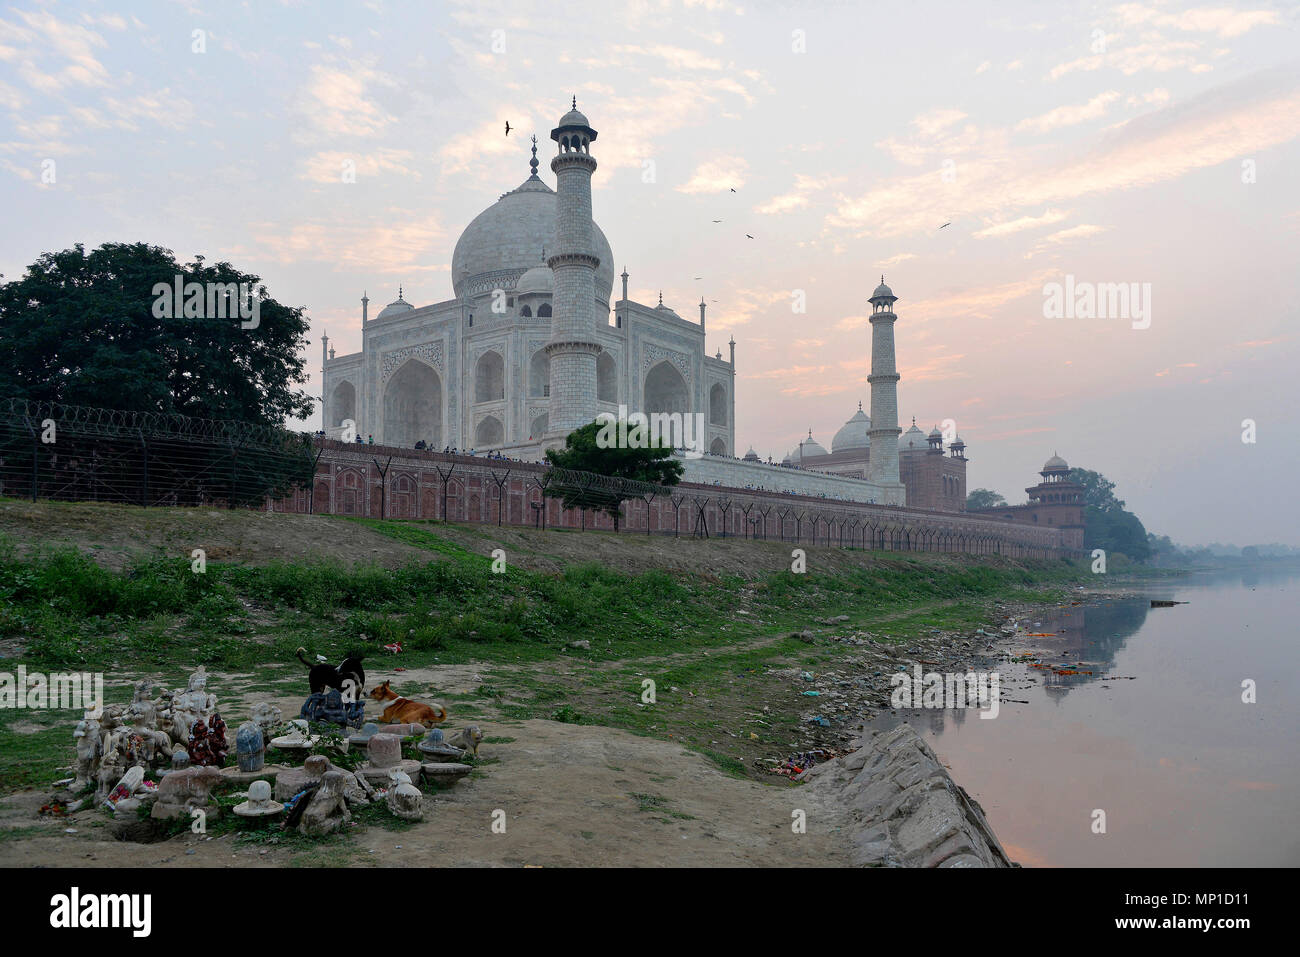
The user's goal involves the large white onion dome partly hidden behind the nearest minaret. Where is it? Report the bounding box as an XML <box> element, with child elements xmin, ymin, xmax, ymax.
<box><xmin>451</xmin><ymin>176</ymin><xmax>614</xmax><ymax>307</ymax></box>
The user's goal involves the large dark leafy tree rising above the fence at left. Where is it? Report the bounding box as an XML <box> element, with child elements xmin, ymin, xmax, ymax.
<box><xmin>0</xmin><ymin>243</ymin><xmax>312</xmax><ymax>425</ymax></box>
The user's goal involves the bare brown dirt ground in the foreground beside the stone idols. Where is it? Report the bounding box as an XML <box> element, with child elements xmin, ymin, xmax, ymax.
<box><xmin>0</xmin><ymin>720</ymin><xmax>848</xmax><ymax>867</ymax></box>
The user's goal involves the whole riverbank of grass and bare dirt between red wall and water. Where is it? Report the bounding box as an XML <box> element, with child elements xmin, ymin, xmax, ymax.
<box><xmin>0</xmin><ymin>505</ymin><xmax>1159</xmax><ymax>865</ymax></box>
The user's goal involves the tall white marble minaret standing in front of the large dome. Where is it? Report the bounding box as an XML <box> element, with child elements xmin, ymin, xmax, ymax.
<box><xmin>546</xmin><ymin>98</ymin><xmax>601</xmax><ymax>445</ymax></box>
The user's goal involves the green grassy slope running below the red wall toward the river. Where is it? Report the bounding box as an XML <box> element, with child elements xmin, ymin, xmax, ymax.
<box><xmin>0</xmin><ymin>510</ymin><xmax>1092</xmax><ymax>791</ymax></box>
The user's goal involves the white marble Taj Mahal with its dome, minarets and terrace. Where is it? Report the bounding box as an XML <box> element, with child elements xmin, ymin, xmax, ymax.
<box><xmin>321</xmin><ymin>100</ymin><xmax>966</xmax><ymax>511</ymax></box>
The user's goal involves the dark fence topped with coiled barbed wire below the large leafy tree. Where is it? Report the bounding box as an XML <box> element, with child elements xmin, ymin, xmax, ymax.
<box><xmin>0</xmin><ymin>399</ymin><xmax>321</xmax><ymax>508</ymax></box>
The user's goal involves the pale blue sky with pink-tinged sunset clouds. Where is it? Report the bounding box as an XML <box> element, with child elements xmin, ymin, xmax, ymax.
<box><xmin>0</xmin><ymin>0</ymin><xmax>1300</xmax><ymax>545</ymax></box>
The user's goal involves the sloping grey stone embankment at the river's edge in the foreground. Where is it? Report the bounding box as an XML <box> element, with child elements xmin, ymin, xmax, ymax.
<box><xmin>801</xmin><ymin>724</ymin><xmax>1017</xmax><ymax>867</ymax></box>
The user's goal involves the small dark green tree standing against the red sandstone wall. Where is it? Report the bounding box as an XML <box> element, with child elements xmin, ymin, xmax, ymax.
<box><xmin>546</xmin><ymin>420</ymin><xmax>685</xmax><ymax>532</ymax></box>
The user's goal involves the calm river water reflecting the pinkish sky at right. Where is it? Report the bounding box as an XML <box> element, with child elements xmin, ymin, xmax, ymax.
<box><xmin>889</xmin><ymin>567</ymin><xmax>1300</xmax><ymax>867</ymax></box>
